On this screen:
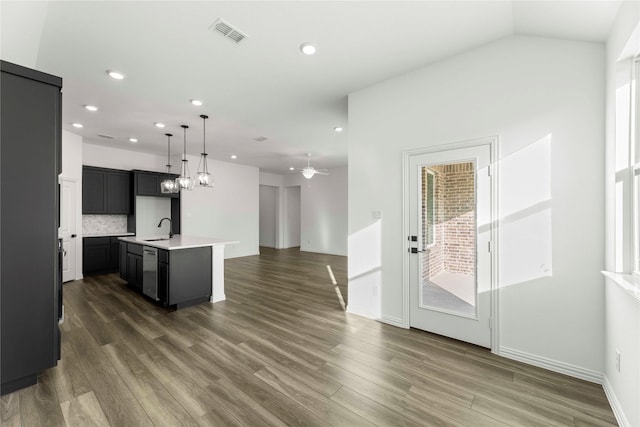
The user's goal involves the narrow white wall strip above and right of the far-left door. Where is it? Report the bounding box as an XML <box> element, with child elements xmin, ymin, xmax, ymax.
<box><xmin>62</xmin><ymin>130</ymin><xmax>82</xmax><ymax>280</ymax></box>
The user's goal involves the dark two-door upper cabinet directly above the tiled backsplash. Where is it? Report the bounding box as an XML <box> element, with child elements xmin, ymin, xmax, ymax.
<box><xmin>82</xmin><ymin>166</ymin><xmax>131</xmax><ymax>215</ymax></box>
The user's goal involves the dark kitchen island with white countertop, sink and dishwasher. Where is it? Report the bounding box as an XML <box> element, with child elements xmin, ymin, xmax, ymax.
<box><xmin>119</xmin><ymin>235</ymin><xmax>238</xmax><ymax>309</ymax></box>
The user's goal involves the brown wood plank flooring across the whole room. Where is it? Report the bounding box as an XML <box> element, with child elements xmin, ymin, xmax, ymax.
<box><xmin>0</xmin><ymin>248</ymin><xmax>616</xmax><ymax>427</ymax></box>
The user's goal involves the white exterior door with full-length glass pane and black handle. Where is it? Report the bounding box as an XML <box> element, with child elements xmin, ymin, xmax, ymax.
<box><xmin>405</xmin><ymin>143</ymin><xmax>493</xmax><ymax>348</ymax></box>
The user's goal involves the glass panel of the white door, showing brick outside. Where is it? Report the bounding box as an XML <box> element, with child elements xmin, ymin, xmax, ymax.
<box><xmin>419</xmin><ymin>161</ymin><xmax>477</xmax><ymax>318</ymax></box>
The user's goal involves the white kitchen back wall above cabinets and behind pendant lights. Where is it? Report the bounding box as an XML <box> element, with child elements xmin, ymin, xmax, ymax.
<box><xmin>83</xmin><ymin>144</ymin><xmax>258</xmax><ymax>258</ymax></box>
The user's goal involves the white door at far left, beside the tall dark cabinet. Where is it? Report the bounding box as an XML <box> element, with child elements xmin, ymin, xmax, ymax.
<box><xmin>58</xmin><ymin>178</ymin><xmax>77</xmax><ymax>282</ymax></box>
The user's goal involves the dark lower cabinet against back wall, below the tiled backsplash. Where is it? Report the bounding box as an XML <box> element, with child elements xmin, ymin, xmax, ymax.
<box><xmin>82</xmin><ymin>236</ymin><xmax>120</xmax><ymax>276</ymax></box>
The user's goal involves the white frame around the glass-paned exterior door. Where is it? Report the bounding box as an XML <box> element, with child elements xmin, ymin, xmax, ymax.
<box><xmin>402</xmin><ymin>135</ymin><xmax>500</xmax><ymax>354</ymax></box>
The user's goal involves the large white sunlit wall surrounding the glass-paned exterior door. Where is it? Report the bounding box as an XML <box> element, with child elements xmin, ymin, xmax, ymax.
<box><xmin>349</xmin><ymin>37</ymin><xmax>604</xmax><ymax>380</ymax></box>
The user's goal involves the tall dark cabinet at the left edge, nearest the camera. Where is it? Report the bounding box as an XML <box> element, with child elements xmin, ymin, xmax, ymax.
<box><xmin>0</xmin><ymin>61</ymin><xmax>62</xmax><ymax>394</ymax></box>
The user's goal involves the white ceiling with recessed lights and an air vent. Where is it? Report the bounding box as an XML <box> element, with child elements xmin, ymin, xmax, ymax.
<box><xmin>0</xmin><ymin>1</ymin><xmax>620</xmax><ymax>173</ymax></box>
